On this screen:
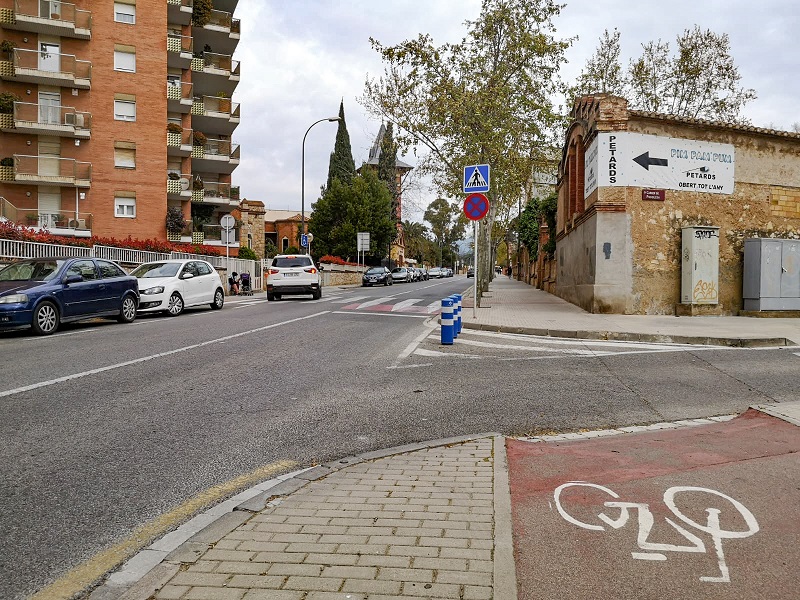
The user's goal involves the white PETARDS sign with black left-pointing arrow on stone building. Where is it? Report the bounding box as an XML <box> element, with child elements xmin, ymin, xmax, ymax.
<box><xmin>584</xmin><ymin>131</ymin><xmax>735</xmax><ymax>197</ymax></box>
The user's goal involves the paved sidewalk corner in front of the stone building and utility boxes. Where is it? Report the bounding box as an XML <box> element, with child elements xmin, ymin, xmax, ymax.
<box><xmin>461</xmin><ymin>276</ymin><xmax>800</xmax><ymax>346</ymax></box>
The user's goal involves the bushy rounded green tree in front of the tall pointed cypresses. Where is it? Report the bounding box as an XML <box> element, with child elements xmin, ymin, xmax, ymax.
<box><xmin>309</xmin><ymin>169</ymin><xmax>395</xmax><ymax>262</ymax></box>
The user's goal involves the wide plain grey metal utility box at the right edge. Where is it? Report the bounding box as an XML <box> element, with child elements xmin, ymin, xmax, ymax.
<box><xmin>742</xmin><ymin>238</ymin><xmax>800</xmax><ymax>310</ymax></box>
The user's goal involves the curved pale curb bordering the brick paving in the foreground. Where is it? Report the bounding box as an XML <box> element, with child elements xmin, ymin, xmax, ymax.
<box><xmin>88</xmin><ymin>432</ymin><xmax>500</xmax><ymax>600</ymax></box>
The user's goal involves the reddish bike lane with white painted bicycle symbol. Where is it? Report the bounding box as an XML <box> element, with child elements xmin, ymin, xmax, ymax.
<box><xmin>507</xmin><ymin>410</ymin><xmax>800</xmax><ymax>600</ymax></box>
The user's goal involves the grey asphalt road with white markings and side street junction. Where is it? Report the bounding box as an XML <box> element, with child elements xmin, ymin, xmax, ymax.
<box><xmin>0</xmin><ymin>277</ymin><xmax>800</xmax><ymax>599</ymax></box>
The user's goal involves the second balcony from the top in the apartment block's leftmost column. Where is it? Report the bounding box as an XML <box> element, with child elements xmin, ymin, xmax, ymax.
<box><xmin>0</xmin><ymin>48</ymin><xmax>92</xmax><ymax>90</ymax></box>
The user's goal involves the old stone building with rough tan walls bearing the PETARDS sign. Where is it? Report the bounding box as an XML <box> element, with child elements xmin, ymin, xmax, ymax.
<box><xmin>552</xmin><ymin>95</ymin><xmax>800</xmax><ymax>314</ymax></box>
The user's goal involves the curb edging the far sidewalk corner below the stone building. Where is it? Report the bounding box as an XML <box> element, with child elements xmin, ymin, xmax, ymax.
<box><xmin>461</xmin><ymin>321</ymin><xmax>796</xmax><ymax>348</ymax></box>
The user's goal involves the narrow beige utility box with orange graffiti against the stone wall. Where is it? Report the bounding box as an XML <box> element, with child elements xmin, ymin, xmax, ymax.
<box><xmin>681</xmin><ymin>226</ymin><xmax>719</xmax><ymax>304</ymax></box>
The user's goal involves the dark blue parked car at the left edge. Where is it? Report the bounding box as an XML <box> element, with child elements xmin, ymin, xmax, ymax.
<box><xmin>0</xmin><ymin>258</ymin><xmax>139</xmax><ymax>335</ymax></box>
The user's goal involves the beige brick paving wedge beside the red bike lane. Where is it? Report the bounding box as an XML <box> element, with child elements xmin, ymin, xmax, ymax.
<box><xmin>153</xmin><ymin>438</ymin><xmax>495</xmax><ymax>600</ymax></box>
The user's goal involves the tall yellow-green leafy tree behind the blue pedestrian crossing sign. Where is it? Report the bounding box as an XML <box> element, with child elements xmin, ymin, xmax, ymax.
<box><xmin>360</xmin><ymin>0</ymin><xmax>570</xmax><ymax>298</ymax></box>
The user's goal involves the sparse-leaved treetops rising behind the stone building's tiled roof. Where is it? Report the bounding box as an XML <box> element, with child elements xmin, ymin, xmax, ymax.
<box><xmin>571</xmin><ymin>25</ymin><xmax>756</xmax><ymax>123</ymax></box>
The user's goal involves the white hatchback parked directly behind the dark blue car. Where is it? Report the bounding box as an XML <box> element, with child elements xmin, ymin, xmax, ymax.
<box><xmin>131</xmin><ymin>260</ymin><xmax>225</xmax><ymax>317</ymax></box>
